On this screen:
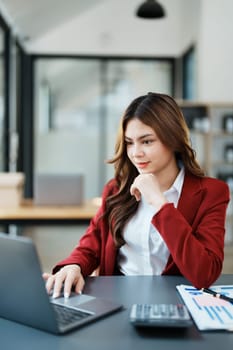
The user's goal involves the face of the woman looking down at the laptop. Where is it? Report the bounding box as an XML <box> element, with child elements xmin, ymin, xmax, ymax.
<box><xmin>125</xmin><ymin>118</ymin><xmax>177</xmax><ymax>176</ymax></box>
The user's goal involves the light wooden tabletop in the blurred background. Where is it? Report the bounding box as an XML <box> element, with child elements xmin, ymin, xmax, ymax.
<box><xmin>0</xmin><ymin>200</ymin><xmax>99</xmax><ymax>224</ymax></box>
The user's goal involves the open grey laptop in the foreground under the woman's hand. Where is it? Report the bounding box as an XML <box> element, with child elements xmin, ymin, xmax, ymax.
<box><xmin>0</xmin><ymin>233</ymin><xmax>122</xmax><ymax>334</ymax></box>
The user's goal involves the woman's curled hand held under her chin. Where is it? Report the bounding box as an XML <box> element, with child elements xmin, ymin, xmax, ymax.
<box><xmin>130</xmin><ymin>174</ymin><xmax>167</xmax><ymax>210</ymax></box>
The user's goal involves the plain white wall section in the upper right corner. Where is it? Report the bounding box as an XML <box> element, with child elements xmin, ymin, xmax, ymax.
<box><xmin>197</xmin><ymin>0</ymin><xmax>233</xmax><ymax>102</ymax></box>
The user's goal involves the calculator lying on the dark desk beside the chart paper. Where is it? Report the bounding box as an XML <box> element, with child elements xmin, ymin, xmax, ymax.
<box><xmin>130</xmin><ymin>304</ymin><xmax>193</xmax><ymax>328</ymax></box>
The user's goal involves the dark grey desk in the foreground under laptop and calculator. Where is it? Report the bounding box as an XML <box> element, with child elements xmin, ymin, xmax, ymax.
<box><xmin>0</xmin><ymin>275</ymin><xmax>233</xmax><ymax>350</ymax></box>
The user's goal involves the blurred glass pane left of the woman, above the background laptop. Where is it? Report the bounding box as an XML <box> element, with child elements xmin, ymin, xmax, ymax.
<box><xmin>34</xmin><ymin>60</ymin><xmax>101</xmax><ymax>197</ymax></box>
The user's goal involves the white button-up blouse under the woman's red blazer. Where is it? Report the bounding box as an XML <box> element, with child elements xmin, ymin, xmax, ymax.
<box><xmin>118</xmin><ymin>168</ymin><xmax>184</xmax><ymax>275</ymax></box>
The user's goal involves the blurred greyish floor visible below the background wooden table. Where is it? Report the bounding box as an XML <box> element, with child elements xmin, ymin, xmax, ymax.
<box><xmin>23</xmin><ymin>226</ymin><xmax>233</xmax><ymax>273</ymax></box>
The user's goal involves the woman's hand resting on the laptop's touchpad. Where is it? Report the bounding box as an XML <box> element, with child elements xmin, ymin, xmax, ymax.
<box><xmin>43</xmin><ymin>265</ymin><xmax>85</xmax><ymax>298</ymax></box>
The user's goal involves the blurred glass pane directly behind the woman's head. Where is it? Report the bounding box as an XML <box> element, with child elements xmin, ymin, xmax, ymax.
<box><xmin>102</xmin><ymin>60</ymin><xmax>173</xmax><ymax>185</ymax></box>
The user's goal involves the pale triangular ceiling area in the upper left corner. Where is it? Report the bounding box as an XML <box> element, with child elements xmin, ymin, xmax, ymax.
<box><xmin>0</xmin><ymin>0</ymin><xmax>106</xmax><ymax>40</ymax></box>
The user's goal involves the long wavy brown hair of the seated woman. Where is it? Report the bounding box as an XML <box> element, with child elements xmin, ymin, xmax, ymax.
<box><xmin>105</xmin><ymin>92</ymin><xmax>204</xmax><ymax>247</ymax></box>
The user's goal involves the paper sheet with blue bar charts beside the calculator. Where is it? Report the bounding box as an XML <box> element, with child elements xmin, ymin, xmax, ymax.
<box><xmin>176</xmin><ymin>284</ymin><xmax>233</xmax><ymax>331</ymax></box>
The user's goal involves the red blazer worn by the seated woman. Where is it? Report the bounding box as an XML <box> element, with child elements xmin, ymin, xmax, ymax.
<box><xmin>53</xmin><ymin>174</ymin><xmax>230</xmax><ymax>288</ymax></box>
